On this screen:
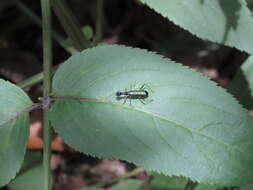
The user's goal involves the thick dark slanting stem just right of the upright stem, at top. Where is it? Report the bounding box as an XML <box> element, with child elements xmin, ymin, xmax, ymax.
<box><xmin>52</xmin><ymin>0</ymin><xmax>91</xmax><ymax>51</ymax></box>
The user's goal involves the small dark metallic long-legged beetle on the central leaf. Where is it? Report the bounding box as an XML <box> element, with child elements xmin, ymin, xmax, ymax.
<box><xmin>116</xmin><ymin>84</ymin><xmax>149</xmax><ymax>105</ymax></box>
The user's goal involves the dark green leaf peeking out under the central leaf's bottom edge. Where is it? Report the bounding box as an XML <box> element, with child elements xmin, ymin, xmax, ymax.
<box><xmin>150</xmin><ymin>173</ymin><xmax>218</xmax><ymax>190</ymax></box>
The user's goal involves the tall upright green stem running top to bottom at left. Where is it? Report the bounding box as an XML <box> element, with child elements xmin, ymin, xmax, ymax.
<box><xmin>41</xmin><ymin>0</ymin><xmax>52</xmax><ymax>190</ymax></box>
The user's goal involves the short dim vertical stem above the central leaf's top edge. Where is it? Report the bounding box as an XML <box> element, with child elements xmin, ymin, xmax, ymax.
<box><xmin>95</xmin><ymin>0</ymin><xmax>104</xmax><ymax>44</ymax></box>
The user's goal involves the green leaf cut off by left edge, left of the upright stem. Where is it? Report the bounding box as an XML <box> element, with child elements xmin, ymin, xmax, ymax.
<box><xmin>0</xmin><ymin>79</ymin><xmax>32</xmax><ymax>186</ymax></box>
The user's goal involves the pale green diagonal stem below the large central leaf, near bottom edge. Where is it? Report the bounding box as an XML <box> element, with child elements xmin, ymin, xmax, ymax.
<box><xmin>88</xmin><ymin>168</ymin><xmax>145</xmax><ymax>189</ymax></box>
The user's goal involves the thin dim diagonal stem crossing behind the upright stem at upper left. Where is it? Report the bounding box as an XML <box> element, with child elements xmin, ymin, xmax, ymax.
<box><xmin>14</xmin><ymin>0</ymin><xmax>78</xmax><ymax>54</ymax></box>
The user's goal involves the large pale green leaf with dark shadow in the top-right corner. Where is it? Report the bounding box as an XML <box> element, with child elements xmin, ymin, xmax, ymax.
<box><xmin>141</xmin><ymin>0</ymin><xmax>253</xmax><ymax>54</ymax></box>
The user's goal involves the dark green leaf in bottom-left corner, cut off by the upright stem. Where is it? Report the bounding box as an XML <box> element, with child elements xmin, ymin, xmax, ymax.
<box><xmin>8</xmin><ymin>165</ymin><xmax>44</xmax><ymax>190</ymax></box>
